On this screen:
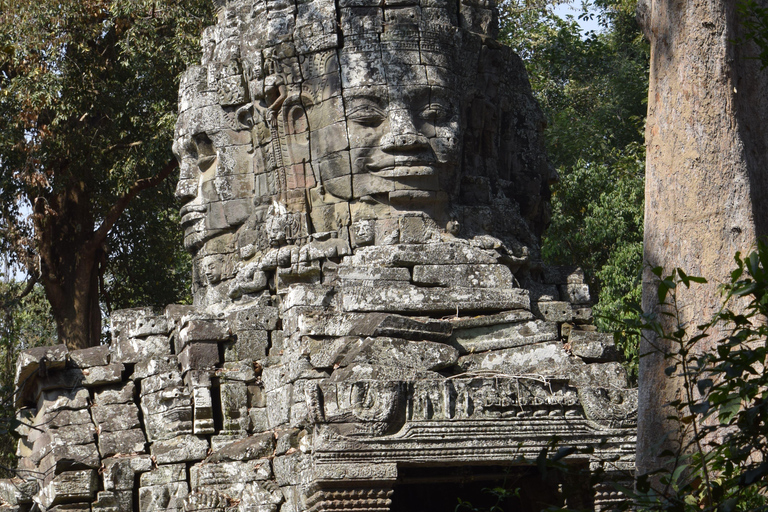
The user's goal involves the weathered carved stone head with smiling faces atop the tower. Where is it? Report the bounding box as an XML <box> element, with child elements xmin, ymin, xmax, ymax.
<box><xmin>174</xmin><ymin>0</ymin><xmax>550</xmax><ymax>306</ymax></box>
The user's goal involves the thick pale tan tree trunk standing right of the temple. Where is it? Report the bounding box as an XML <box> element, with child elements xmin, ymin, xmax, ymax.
<box><xmin>637</xmin><ymin>0</ymin><xmax>768</xmax><ymax>474</ymax></box>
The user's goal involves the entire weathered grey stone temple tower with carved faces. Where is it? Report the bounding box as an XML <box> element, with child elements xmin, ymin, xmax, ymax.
<box><xmin>0</xmin><ymin>0</ymin><xmax>637</xmax><ymax>512</ymax></box>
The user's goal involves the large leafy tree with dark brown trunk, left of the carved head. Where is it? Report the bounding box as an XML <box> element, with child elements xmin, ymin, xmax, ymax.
<box><xmin>0</xmin><ymin>0</ymin><xmax>213</xmax><ymax>347</ymax></box>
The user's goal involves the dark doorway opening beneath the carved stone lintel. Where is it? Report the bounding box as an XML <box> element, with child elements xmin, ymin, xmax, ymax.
<box><xmin>391</xmin><ymin>466</ymin><xmax>592</xmax><ymax>512</ymax></box>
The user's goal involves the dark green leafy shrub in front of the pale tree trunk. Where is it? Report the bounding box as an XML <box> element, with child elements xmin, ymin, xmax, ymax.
<box><xmin>626</xmin><ymin>246</ymin><xmax>768</xmax><ymax>512</ymax></box>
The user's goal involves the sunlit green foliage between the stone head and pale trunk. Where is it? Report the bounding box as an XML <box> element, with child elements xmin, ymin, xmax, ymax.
<box><xmin>501</xmin><ymin>0</ymin><xmax>650</xmax><ymax>375</ymax></box>
